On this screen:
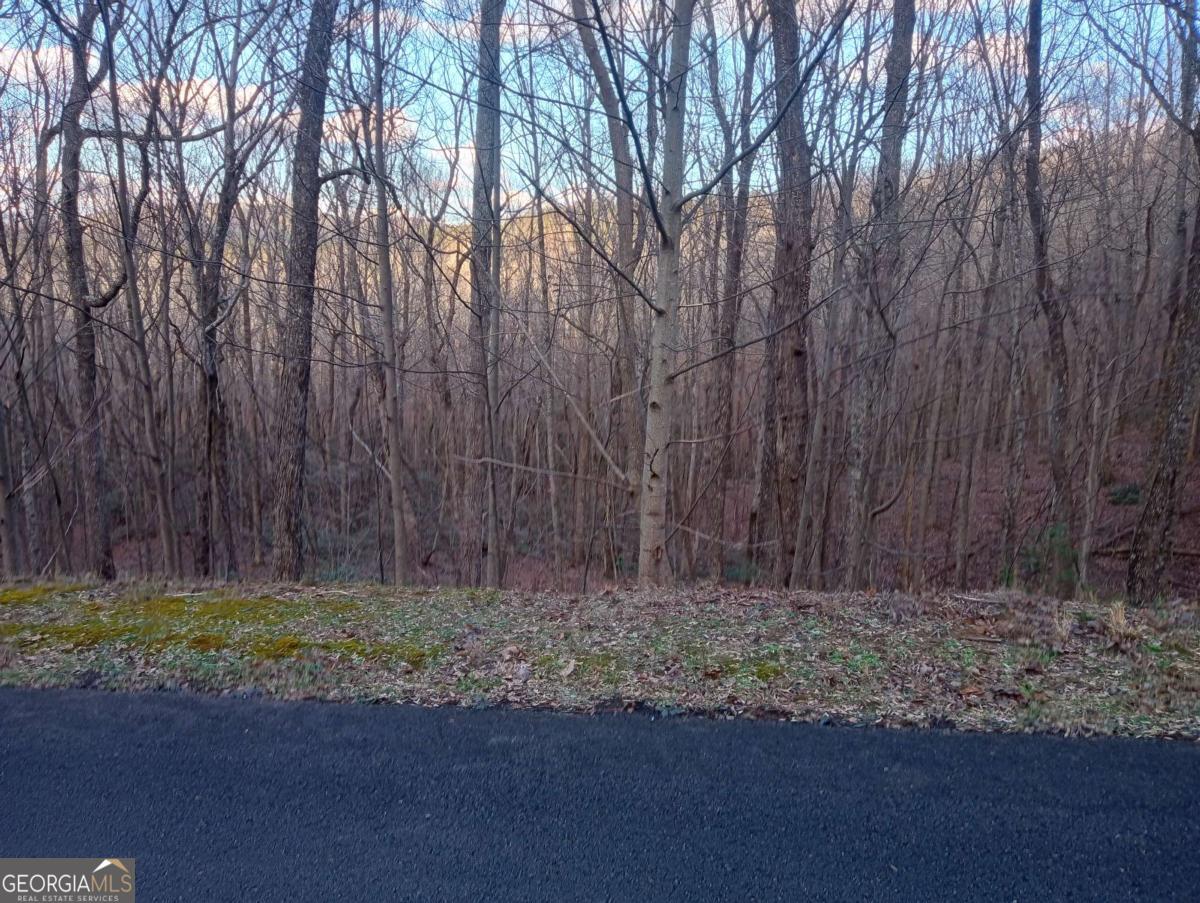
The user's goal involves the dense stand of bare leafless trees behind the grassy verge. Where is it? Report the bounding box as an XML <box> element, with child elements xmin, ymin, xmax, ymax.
<box><xmin>0</xmin><ymin>0</ymin><xmax>1200</xmax><ymax>604</ymax></box>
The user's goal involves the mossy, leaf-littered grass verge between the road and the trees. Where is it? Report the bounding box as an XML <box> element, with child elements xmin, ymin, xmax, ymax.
<box><xmin>0</xmin><ymin>584</ymin><xmax>1200</xmax><ymax>738</ymax></box>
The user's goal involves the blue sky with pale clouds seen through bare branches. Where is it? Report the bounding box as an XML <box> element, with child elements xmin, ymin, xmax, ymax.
<box><xmin>0</xmin><ymin>0</ymin><xmax>1175</xmax><ymax>232</ymax></box>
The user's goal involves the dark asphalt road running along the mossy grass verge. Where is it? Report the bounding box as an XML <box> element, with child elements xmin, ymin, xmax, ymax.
<box><xmin>0</xmin><ymin>689</ymin><xmax>1200</xmax><ymax>903</ymax></box>
